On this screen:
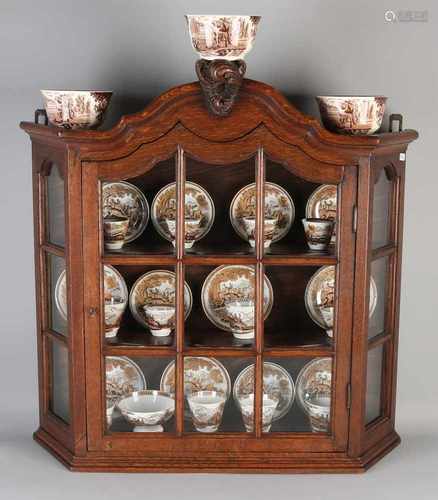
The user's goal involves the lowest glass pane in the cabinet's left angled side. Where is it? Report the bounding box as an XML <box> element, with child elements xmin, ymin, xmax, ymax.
<box><xmin>49</xmin><ymin>340</ymin><xmax>70</xmax><ymax>423</ymax></box>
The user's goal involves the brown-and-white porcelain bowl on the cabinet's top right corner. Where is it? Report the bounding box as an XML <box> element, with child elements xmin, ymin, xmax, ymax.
<box><xmin>316</xmin><ymin>96</ymin><xmax>387</xmax><ymax>135</ymax></box>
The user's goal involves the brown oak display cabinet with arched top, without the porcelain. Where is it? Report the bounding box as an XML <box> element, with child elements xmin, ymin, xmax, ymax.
<box><xmin>21</xmin><ymin>80</ymin><xmax>417</xmax><ymax>472</ymax></box>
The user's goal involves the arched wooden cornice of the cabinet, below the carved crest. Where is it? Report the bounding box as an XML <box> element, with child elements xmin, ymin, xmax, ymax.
<box><xmin>21</xmin><ymin>80</ymin><xmax>418</xmax><ymax>168</ymax></box>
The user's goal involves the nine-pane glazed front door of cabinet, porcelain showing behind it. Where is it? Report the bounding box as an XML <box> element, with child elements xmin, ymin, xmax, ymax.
<box><xmin>84</xmin><ymin>138</ymin><xmax>356</xmax><ymax>451</ymax></box>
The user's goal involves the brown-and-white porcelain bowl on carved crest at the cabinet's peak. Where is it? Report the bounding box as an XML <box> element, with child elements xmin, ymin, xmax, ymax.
<box><xmin>186</xmin><ymin>15</ymin><xmax>260</xmax><ymax>61</ymax></box>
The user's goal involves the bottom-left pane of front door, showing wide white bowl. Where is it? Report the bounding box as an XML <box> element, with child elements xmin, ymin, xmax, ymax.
<box><xmin>105</xmin><ymin>356</ymin><xmax>175</xmax><ymax>433</ymax></box>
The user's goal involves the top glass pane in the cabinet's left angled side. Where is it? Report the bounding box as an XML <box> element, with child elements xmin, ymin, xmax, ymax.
<box><xmin>46</xmin><ymin>164</ymin><xmax>65</xmax><ymax>247</ymax></box>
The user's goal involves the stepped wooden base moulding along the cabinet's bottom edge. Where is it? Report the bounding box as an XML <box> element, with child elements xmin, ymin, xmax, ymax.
<box><xmin>34</xmin><ymin>428</ymin><xmax>400</xmax><ymax>474</ymax></box>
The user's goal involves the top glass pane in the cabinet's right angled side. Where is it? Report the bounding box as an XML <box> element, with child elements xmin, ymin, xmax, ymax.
<box><xmin>372</xmin><ymin>169</ymin><xmax>394</xmax><ymax>248</ymax></box>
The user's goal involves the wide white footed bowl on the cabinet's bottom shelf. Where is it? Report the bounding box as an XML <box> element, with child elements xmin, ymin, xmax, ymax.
<box><xmin>117</xmin><ymin>390</ymin><xmax>175</xmax><ymax>432</ymax></box>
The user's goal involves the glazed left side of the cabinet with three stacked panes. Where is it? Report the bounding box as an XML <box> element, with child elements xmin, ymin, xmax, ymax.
<box><xmin>36</xmin><ymin>158</ymin><xmax>72</xmax><ymax>430</ymax></box>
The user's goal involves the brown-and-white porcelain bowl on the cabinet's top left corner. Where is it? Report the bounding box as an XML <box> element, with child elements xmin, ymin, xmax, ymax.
<box><xmin>41</xmin><ymin>90</ymin><xmax>112</xmax><ymax>129</ymax></box>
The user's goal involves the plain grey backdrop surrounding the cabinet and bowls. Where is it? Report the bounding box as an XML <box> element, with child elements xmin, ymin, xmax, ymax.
<box><xmin>0</xmin><ymin>0</ymin><xmax>438</xmax><ymax>500</ymax></box>
